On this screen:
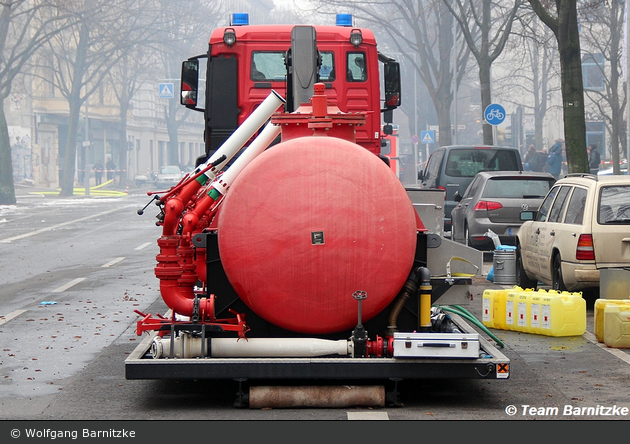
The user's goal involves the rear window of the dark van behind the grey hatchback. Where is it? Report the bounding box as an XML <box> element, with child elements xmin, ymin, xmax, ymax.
<box><xmin>446</xmin><ymin>148</ymin><xmax>519</xmax><ymax>177</ymax></box>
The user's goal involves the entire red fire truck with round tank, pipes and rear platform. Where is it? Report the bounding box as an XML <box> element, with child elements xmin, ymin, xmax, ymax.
<box><xmin>125</xmin><ymin>16</ymin><xmax>509</xmax><ymax>406</ymax></box>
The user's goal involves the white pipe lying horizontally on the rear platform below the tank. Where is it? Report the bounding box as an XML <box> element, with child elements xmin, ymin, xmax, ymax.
<box><xmin>151</xmin><ymin>334</ymin><xmax>351</xmax><ymax>359</ymax></box>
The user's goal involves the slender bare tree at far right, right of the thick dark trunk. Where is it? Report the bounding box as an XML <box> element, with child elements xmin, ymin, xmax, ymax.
<box><xmin>580</xmin><ymin>0</ymin><xmax>627</xmax><ymax>174</ymax></box>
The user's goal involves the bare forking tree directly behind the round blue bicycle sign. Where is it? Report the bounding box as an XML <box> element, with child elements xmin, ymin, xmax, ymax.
<box><xmin>443</xmin><ymin>0</ymin><xmax>522</xmax><ymax>145</ymax></box>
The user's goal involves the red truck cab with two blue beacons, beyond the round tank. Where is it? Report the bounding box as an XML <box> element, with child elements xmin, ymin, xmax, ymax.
<box><xmin>182</xmin><ymin>14</ymin><xmax>401</xmax><ymax>161</ymax></box>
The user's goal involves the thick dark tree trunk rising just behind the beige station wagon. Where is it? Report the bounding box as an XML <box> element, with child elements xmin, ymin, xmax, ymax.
<box><xmin>529</xmin><ymin>0</ymin><xmax>590</xmax><ymax>173</ymax></box>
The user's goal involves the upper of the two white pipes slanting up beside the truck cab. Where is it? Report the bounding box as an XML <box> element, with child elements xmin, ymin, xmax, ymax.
<box><xmin>198</xmin><ymin>90</ymin><xmax>285</xmax><ymax>181</ymax></box>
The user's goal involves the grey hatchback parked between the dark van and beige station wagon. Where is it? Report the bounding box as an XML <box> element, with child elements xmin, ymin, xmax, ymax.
<box><xmin>451</xmin><ymin>171</ymin><xmax>556</xmax><ymax>249</ymax></box>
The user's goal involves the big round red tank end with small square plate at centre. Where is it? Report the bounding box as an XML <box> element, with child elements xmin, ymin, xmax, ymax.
<box><xmin>217</xmin><ymin>136</ymin><xmax>417</xmax><ymax>334</ymax></box>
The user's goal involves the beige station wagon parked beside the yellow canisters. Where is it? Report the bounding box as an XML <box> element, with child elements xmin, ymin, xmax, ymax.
<box><xmin>516</xmin><ymin>174</ymin><xmax>630</xmax><ymax>293</ymax></box>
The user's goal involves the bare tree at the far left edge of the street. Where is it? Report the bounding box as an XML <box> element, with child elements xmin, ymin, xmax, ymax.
<box><xmin>0</xmin><ymin>0</ymin><xmax>70</xmax><ymax>204</ymax></box>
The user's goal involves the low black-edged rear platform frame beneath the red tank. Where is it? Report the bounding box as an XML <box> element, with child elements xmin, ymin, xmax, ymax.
<box><xmin>125</xmin><ymin>315</ymin><xmax>510</xmax><ymax>380</ymax></box>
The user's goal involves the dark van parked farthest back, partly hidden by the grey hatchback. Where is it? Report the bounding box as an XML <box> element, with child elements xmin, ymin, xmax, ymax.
<box><xmin>418</xmin><ymin>145</ymin><xmax>523</xmax><ymax>232</ymax></box>
